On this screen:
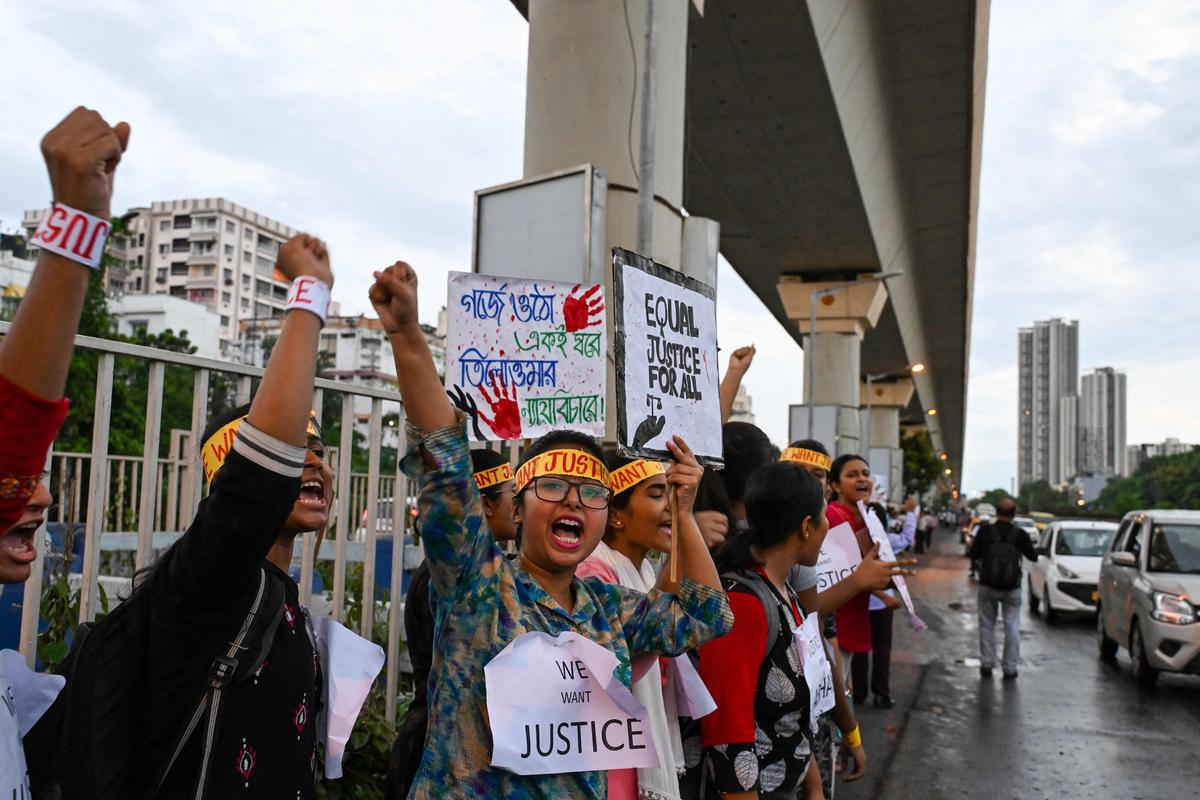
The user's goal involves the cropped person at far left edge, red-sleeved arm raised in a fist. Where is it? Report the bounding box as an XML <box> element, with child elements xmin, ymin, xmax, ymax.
<box><xmin>0</xmin><ymin>107</ymin><xmax>130</xmax><ymax>798</ymax></box>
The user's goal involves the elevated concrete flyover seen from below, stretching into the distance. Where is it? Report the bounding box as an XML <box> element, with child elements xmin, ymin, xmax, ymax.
<box><xmin>511</xmin><ymin>0</ymin><xmax>989</xmax><ymax>483</ymax></box>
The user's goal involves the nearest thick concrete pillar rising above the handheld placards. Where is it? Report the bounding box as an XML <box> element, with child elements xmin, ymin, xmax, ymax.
<box><xmin>524</xmin><ymin>0</ymin><xmax>700</xmax><ymax>275</ymax></box>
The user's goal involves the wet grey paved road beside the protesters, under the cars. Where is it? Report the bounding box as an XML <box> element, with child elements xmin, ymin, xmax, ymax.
<box><xmin>835</xmin><ymin>531</ymin><xmax>1200</xmax><ymax>800</ymax></box>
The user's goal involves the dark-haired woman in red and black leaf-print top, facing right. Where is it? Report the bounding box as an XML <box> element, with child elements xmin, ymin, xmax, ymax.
<box><xmin>700</xmin><ymin>463</ymin><xmax>828</xmax><ymax>800</ymax></box>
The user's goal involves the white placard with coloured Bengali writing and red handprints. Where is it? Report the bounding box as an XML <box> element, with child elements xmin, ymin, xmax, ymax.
<box><xmin>445</xmin><ymin>272</ymin><xmax>606</xmax><ymax>441</ymax></box>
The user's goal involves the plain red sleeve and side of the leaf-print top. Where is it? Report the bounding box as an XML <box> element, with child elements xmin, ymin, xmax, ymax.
<box><xmin>700</xmin><ymin>591</ymin><xmax>767</xmax><ymax>747</ymax></box>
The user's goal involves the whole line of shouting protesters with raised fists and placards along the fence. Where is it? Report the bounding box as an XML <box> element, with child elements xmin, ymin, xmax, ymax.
<box><xmin>0</xmin><ymin>108</ymin><xmax>914</xmax><ymax>800</ymax></box>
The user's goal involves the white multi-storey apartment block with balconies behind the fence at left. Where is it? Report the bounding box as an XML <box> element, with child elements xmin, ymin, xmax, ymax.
<box><xmin>22</xmin><ymin>198</ymin><xmax>304</xmax><ymax>355</ymax></box>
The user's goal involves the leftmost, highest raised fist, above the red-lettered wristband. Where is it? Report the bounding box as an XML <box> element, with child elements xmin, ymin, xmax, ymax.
<box><xmin>42</xmin><ymin>106</ymin><xmax>130</xmax><ymax>221</ymax></box>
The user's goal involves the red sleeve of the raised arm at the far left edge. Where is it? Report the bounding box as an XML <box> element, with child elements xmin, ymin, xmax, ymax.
<box><xmin>0</xmin><ymin>375</ymin><xmax>70</xmax><ymax>531</ymax></box>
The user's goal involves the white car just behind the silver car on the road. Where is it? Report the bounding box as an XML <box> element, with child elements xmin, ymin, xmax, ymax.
<box><xmin>1027</xmin><ymin>519</ymin><xmax>1117</xmax><ymax>622</ymax></box>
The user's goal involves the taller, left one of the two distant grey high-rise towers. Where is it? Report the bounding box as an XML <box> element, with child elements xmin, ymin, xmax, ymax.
<box><xmin>1016</xmin><ymin>319</ymin><xmax>1079</xmax><ymax>486</ymax></box>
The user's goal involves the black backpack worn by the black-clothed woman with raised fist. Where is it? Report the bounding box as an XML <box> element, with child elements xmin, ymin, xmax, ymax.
<box><xmin>24</xmin><ymin>570</ymin><xmax>284</xmax><ymax>800</ymax></box>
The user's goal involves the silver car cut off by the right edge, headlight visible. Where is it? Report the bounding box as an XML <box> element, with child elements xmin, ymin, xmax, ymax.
<box><xmin>1096</xmin><ymin>510</ymin><xmax>1200</xmax><ymax>686</ymax></box>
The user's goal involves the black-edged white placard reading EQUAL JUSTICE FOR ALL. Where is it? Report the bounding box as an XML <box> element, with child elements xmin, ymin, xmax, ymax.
<box><xmin>612</xmin><ymin>247</ymin><xmax>724</xmax><ymax>467</ymax></box>
